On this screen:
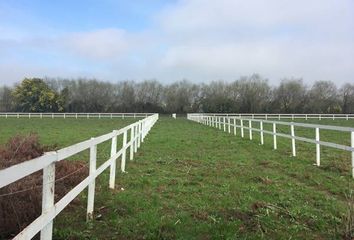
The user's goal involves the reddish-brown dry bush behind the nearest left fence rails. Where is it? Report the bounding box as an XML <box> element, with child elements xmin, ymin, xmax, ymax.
<box><xmin>0</xmin><ymin>134</ymin><xmax>88</xmax><ymax>239</ymax></box>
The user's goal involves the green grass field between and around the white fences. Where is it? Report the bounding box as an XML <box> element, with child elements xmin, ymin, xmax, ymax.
<box><xmin>0</xmin><ymin>118</ymin><xmax>354</xmax><ymax>239</ymax></box>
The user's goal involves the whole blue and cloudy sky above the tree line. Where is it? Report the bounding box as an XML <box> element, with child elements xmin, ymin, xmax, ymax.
<box><xmin>0</xmin><ymin>0</ymin><xmax>354</xmax><ymax>85</ymax></box>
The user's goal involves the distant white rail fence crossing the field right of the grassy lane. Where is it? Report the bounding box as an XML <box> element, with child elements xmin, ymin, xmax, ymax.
<box><xmin>194</xmin><ymin>113</ymin><xmax>354</xmax><ymax>120</ymax></box>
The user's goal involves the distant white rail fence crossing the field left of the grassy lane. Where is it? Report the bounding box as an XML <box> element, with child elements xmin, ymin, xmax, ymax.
<box><xmin>0</xmin><ymin>112</ymin><xmax>154</xmax><ymax>118</ymax></box>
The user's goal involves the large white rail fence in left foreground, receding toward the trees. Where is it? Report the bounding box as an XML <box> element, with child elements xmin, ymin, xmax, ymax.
<box><xmin>0</xmin><ymin>114</ymin><xmax>159</xmax><ymax>240</ymax></box>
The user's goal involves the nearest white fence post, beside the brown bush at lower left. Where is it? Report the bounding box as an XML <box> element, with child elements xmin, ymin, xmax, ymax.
<box><xmin>40</xmin><ymin>158</ymin><xmax>55</xmax><ymax>240</ymax></box>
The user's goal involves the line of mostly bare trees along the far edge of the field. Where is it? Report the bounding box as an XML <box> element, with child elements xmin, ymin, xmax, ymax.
<box><xmin>0</xmin><ymin>74</ymin><xmax>354</xmax><ymax>113</ymax></box>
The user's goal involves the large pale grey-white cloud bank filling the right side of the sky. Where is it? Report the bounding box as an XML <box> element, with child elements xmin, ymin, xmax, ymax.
<box><xmin>157</xmin><ymin>0</ymin><xmax>354</xmax><ymax>83</ymax></box>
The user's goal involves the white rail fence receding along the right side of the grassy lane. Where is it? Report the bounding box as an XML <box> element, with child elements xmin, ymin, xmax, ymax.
<box><xmin>187</xmin><ymin>114</ymin><xmax>354</xmax><ymax>178</ymax></box>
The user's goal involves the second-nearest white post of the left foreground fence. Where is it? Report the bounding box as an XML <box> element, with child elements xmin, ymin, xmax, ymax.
<box><xmin>86</xmin><ymin>138</ymin><xmax>97</xmax><ymax>221</ymax></box>
